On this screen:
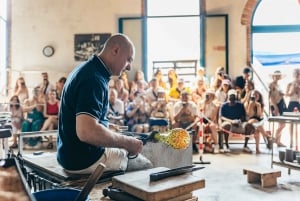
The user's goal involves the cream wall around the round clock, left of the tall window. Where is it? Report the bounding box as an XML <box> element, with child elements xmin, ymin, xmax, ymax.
<box><xmin>9</xmin><ymin>0</ymin><xmax>141</xmax><ymax>90</ymax></box>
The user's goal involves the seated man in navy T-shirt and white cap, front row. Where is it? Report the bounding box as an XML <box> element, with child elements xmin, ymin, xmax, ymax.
<box><xmin>219</xmin><ymin>89</ymin><xmax>255</xmax><ymax>153</ymax></box>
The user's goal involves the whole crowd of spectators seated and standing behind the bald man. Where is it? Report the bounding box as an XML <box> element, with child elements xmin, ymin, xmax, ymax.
<box><xmin>1</xmin><ymin>67</ymin><xmax>300</xmax><ymax>153</ymax></box>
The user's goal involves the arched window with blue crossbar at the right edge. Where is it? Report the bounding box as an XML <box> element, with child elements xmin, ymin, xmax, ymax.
<box><xmin>251</xmin><ymin>0</ymin><xmax>300</xmax><ymax>80</ymax></box>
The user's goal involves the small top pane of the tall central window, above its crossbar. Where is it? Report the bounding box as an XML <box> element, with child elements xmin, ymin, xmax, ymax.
<box><xmin>147</xmin><ymin>0</ymin><xmax>200</xmax><ymax>16</ymax></box>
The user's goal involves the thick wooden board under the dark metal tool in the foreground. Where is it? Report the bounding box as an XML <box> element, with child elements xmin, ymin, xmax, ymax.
<box><xmin>112</xmin><ymin>167</ymin><xmax>205</xmax><ymax>201</ymax></box>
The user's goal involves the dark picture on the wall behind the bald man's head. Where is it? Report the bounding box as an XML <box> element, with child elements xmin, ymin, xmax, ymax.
<box><xmin>74</xmin><ymin>33</ymin><xmax>111</xmax><ymax>61</ymax></box>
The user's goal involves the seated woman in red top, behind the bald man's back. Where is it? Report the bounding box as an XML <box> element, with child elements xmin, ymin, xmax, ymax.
<box><xmin>41</xmin><ymin>89</ymin><xmax>59</xmax><ymax>149</ymax></box>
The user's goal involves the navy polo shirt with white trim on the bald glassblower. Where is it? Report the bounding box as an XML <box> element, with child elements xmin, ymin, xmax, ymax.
<box><xmin>57</xmin><ymin>55</ymin><xmax>110</xmax><ymax>170</ymax></box>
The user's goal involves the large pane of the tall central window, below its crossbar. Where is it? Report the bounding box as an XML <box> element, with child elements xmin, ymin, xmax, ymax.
<box><xmin>147</xmin><ymin>17</ymin><xmax>200</xmax><ymax>80</ymax></box>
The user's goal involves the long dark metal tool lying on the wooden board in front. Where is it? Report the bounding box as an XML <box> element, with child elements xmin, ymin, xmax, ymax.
<box><xmin>150</xmin><ymin>165</ymin><xmax>204</xmax><ymax>181</ymax></box>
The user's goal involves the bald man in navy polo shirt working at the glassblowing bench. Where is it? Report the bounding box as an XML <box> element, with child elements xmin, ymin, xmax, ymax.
<box><xmin>57</xmin><ymin>34</ymin><xmax>152</xmax><ymax>174</ymax></box>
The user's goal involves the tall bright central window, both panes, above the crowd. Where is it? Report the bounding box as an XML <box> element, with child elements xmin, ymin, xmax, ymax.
<box><xmin>144</xmin><ymin>0</ymin><xmax>200</xmax><ymax>80</ymax></box>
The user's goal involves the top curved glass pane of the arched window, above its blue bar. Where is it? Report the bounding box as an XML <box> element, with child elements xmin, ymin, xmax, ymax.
<box><xmin>253</xmin><ymin>0</ymin><xmax>300</xmax><ymax>25</ymax></box>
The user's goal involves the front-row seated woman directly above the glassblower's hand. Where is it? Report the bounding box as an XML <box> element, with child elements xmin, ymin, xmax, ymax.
<box><xmin>126</xmin><ymin>92</ymin><xmax>150</xmax><ymax>133</ymax></box>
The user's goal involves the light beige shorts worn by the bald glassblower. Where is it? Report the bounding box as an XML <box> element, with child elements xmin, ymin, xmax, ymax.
<box><xmin>65</xmin><ymin>148</ymin><xmax>128</xmax><ymax>174</ymax></box>
